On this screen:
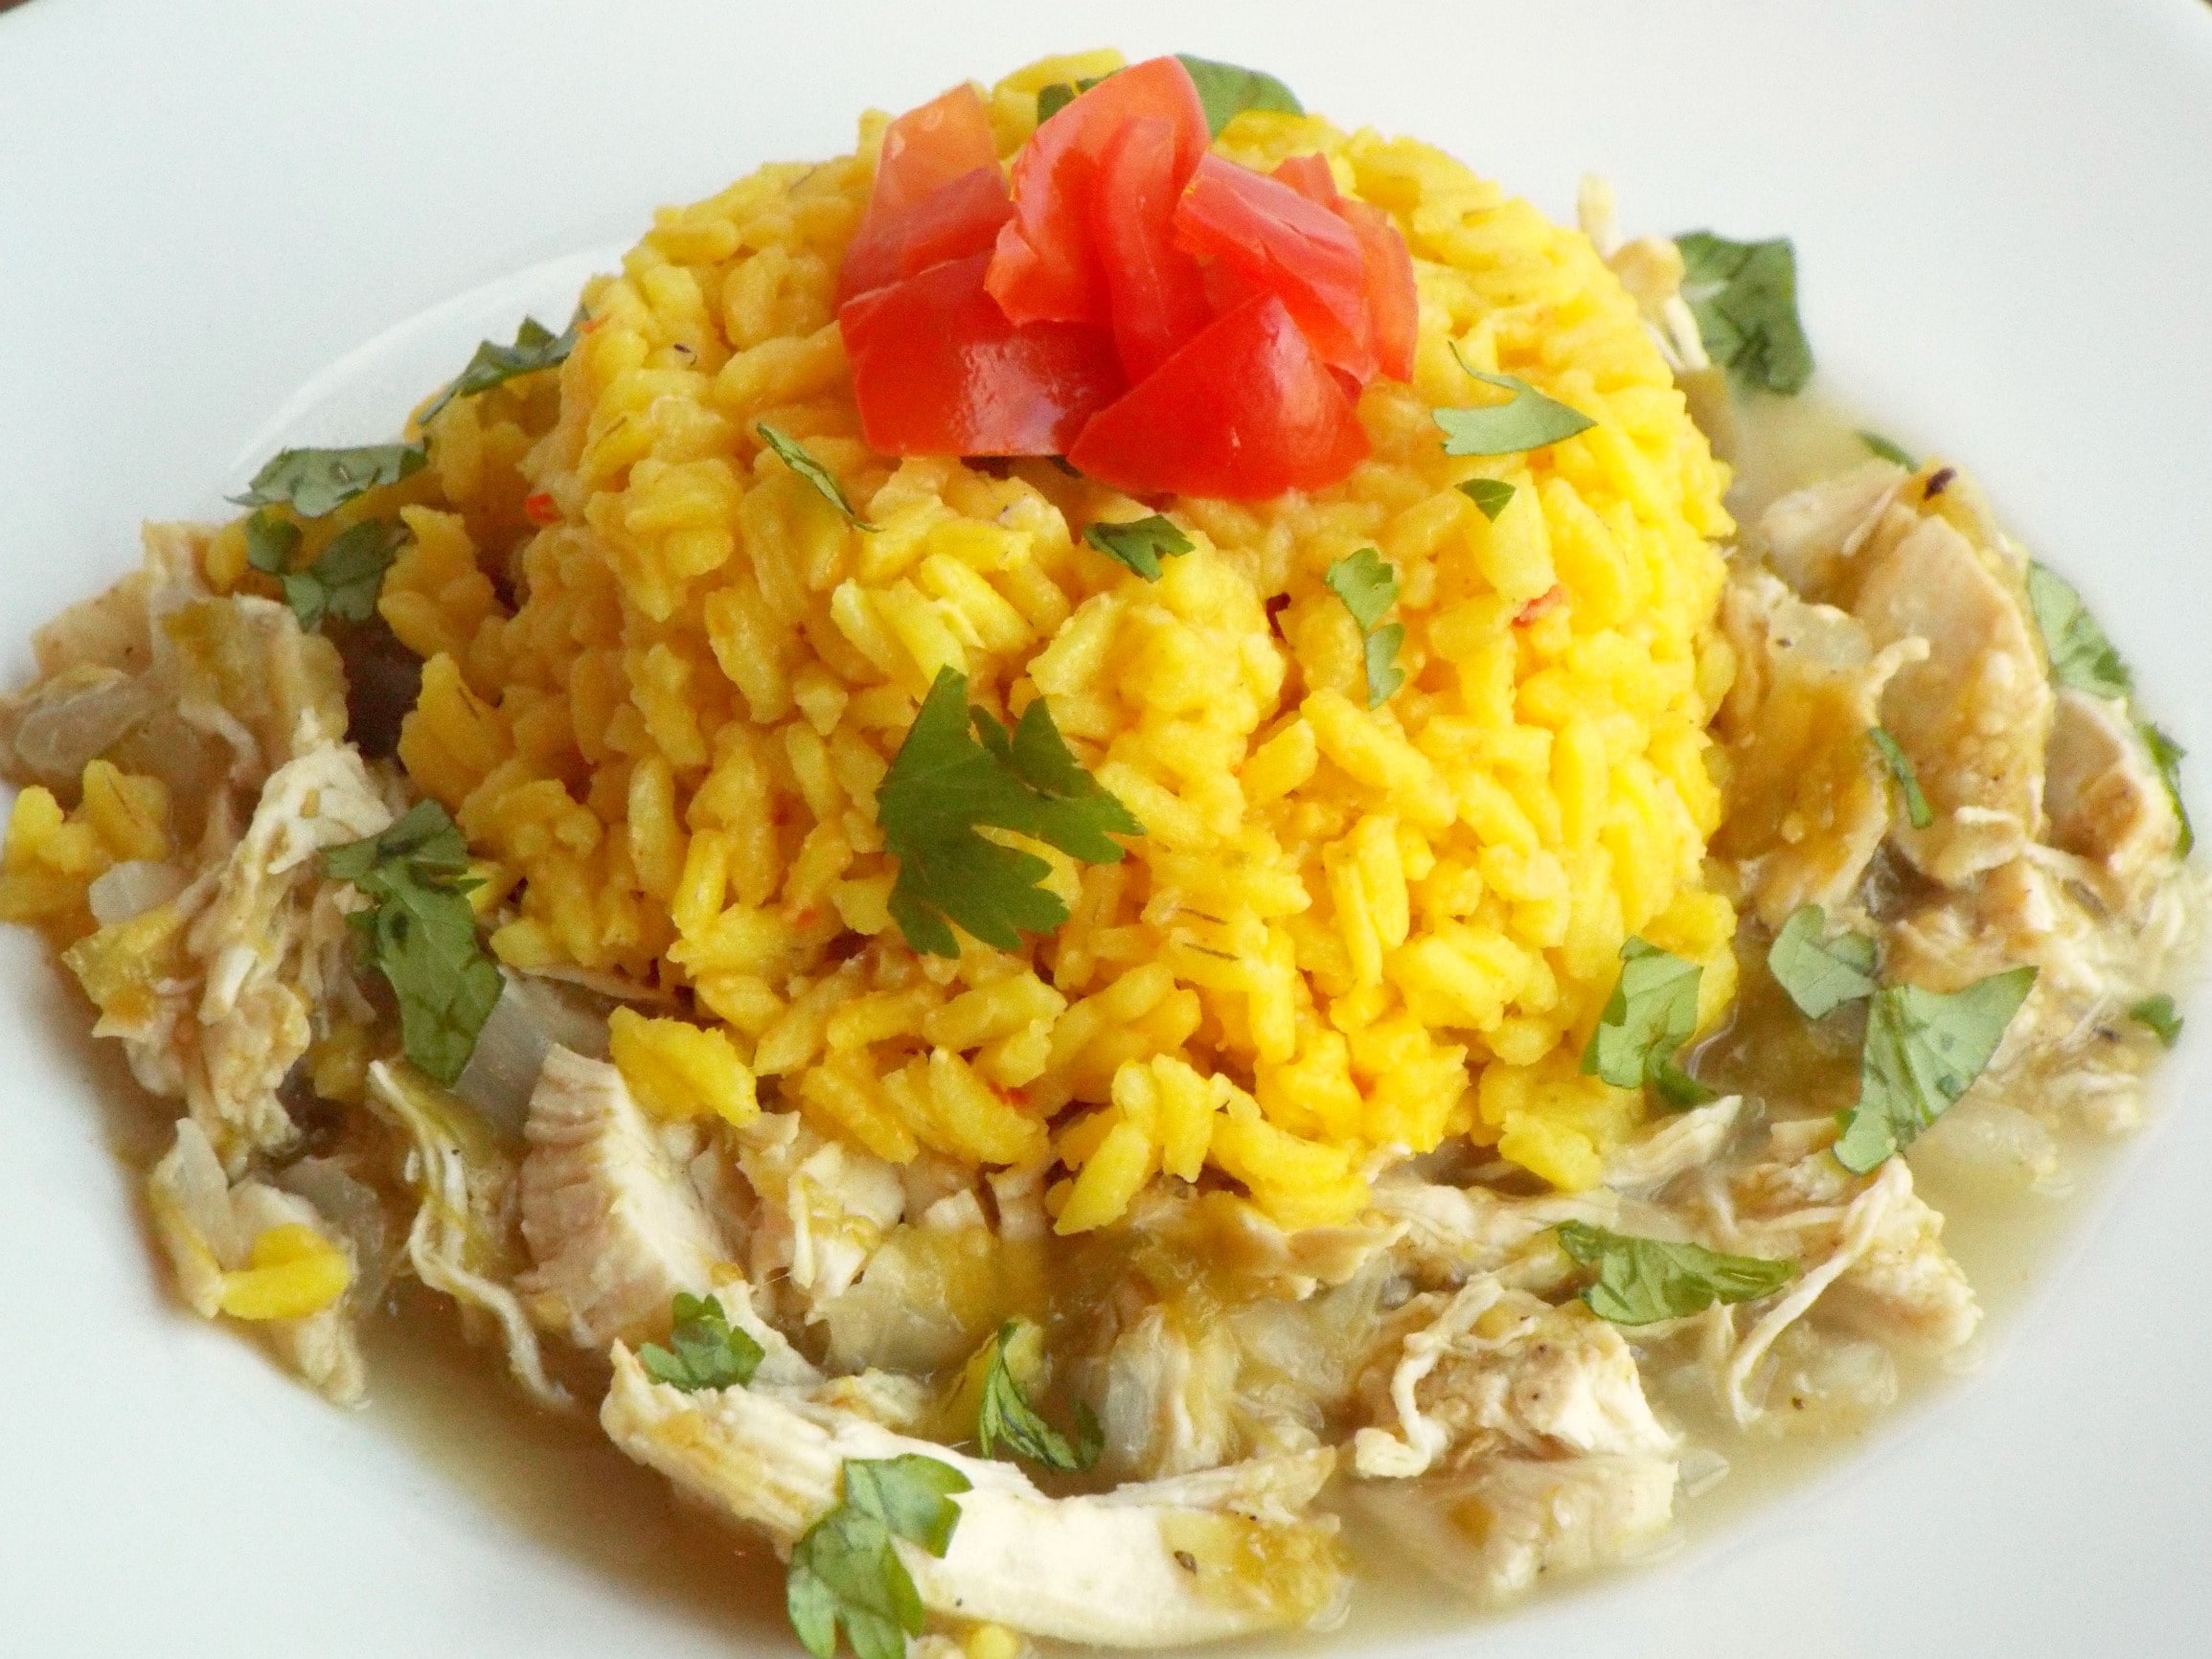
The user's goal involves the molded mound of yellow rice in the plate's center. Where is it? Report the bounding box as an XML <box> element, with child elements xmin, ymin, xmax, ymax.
<box><xmin>190</xmin><ymin>53</ymin><xmax>1734</xmax><ymax>1232</ymax></box>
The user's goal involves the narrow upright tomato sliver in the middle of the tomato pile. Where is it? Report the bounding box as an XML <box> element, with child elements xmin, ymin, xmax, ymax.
<box><xmin>1090</xmin><ymin>115</ymin><xmax>1215</xmax><ymax>385</ymax></box>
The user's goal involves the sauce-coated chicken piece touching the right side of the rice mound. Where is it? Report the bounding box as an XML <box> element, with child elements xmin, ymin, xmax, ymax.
<box><xmin>1712</xmin><ymin>571</ymin><xmax>1927</xmax><ymax>927</ymax></box>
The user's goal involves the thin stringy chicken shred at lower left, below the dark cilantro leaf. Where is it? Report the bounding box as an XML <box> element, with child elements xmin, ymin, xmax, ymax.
<box><xmin>367</xmin><ymin>1059</ymin><xmax>571</xmax><ymax>1407</ymax></box>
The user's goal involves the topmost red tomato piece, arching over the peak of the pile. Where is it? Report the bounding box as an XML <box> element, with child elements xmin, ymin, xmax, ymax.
<box><xmin>989</xmin><ymin>57</ymin><xmax>1210</xmax><ymax>325</ymax></box>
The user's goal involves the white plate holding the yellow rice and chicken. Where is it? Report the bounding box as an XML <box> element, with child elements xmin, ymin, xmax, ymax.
<box><xmin>0</xmin><ymin>0</ymin><xmax>2212</xmax><ymax>1659</ymax></box>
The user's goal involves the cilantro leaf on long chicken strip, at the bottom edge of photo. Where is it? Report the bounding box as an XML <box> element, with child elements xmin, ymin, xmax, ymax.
<box><xmin>783</xmin><ymin>1453</ymin><xmax>969</xmax><ymax>1659</ymax></box>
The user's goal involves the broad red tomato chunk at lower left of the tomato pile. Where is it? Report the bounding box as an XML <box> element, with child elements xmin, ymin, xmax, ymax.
<box><xmin>838</xmin><ymin>255</ymin><xmax>1126</xmax><ymax>456</ymax></box>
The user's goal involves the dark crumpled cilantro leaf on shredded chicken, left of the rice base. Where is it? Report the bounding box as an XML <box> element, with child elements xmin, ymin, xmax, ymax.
<box><xmin>323</xmin><ymin>801</ymin><xmax>504</xmax><ymax>1086</ymax></box>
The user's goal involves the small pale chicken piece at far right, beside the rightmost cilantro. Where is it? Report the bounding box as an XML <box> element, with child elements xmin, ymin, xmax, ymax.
<box><xmin>2044</xmin><ymin>688</ymin><xmax>2181</xmax><ymax>905</ymax></box>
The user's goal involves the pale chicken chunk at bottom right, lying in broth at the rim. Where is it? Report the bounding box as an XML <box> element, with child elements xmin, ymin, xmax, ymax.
<box><xmin>1356</xmin><ymin>1453</ymin><xmax>1675</xmax><ymax>1606</ymax></box>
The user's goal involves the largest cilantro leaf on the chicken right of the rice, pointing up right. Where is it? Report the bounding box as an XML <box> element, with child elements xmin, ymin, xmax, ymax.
<box><xmin>1836</xmin><ymin>966</ymin><xmax>2035</xmax><ymax>1174</ymax></box>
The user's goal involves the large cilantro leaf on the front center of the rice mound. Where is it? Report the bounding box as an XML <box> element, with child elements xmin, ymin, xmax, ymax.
<box><xmin>876</xmin><ymin>668</ymin><xmax>1144</xmax><ymax>956</ymax></box>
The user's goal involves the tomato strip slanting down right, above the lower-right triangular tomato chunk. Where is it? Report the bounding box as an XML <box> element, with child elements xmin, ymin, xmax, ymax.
<box><xmin>1174</xmin><ymin>155</ymin><xmax>1376</xmax><ymax>385</ymax></box>
